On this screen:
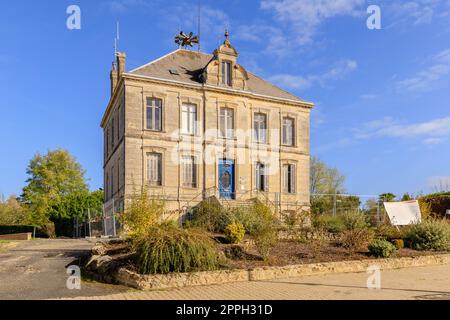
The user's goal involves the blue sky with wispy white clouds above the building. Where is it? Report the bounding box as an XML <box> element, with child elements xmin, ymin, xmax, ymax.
<box><xmin>0</xmin><ymin>0</ymin><xmax>450</xmax><ymax>196</ymax></box>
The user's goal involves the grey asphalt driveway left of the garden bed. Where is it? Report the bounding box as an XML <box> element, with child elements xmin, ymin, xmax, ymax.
<box><xmin>0</xmin><ymin>240</ymin><xmax>128</xmax><ymax>300</ymax></box>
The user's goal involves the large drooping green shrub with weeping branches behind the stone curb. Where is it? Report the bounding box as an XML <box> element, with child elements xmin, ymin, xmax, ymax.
<box><xmin>133</xmin><ymin>224</ymin><xmax>219</xmax><ymax>274</ymax></box>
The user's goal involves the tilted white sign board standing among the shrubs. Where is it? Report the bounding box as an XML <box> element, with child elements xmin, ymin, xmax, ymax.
<box><xmin>384</xmin><ymin>200</ymin><xmax>422</xmax><ymax>226</ymax></box>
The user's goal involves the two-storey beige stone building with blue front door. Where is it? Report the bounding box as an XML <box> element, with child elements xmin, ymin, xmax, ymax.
<box><xmin>101</xmin><ymin>35</ymin><xmax>313</xmax><ymax>221</ymax></box>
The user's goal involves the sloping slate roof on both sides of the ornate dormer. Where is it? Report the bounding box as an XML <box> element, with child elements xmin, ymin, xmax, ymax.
<box><xmin>128</xmin><ymin>49</ymin><xmax>304</xmax><ymax>102</ymax></box>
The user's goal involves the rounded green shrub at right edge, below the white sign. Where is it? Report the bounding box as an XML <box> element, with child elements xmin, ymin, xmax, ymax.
<box><xmin>406</xmin><ymin>220</ymin><xmax>450</xmax><ymax>251</ymax></box>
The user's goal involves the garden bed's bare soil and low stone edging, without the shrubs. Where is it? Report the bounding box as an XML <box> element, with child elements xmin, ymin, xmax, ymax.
<box><xmin>85</xmin><ymin>241</ymin><xmax>450</xmax><ymax>290</ymax></box>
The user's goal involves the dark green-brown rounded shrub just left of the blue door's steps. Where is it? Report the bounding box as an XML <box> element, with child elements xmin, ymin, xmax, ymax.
<box><xmin>190</xmin><ymin>200</ymin><xmax>233</xmax><ymax>233</ymax></box>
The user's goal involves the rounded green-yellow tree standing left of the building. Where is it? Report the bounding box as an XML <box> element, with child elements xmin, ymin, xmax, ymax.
<box><xmin>21</xmin><ymin>149</ymin><xmax>88</xmax><ymax>233</ymax></box>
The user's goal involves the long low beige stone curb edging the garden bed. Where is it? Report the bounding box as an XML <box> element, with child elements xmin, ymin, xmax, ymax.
<box><xmin>110</xmin><ymin>254</ymin><xmax>450</xmax><ymax>291</ymax></box>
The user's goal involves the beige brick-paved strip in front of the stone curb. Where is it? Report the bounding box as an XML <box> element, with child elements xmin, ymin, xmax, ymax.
<box><xmin>72</xmin><ymin>265</ymin><xmax>450</xmax><ymax>300</ymax></box>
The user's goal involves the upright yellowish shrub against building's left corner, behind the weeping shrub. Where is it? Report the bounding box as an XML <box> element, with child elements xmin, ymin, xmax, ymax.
<box><xmin>119</xmin><ymin>187</ymin><xmax>165</xmax><ymax>235</ymax></box>
